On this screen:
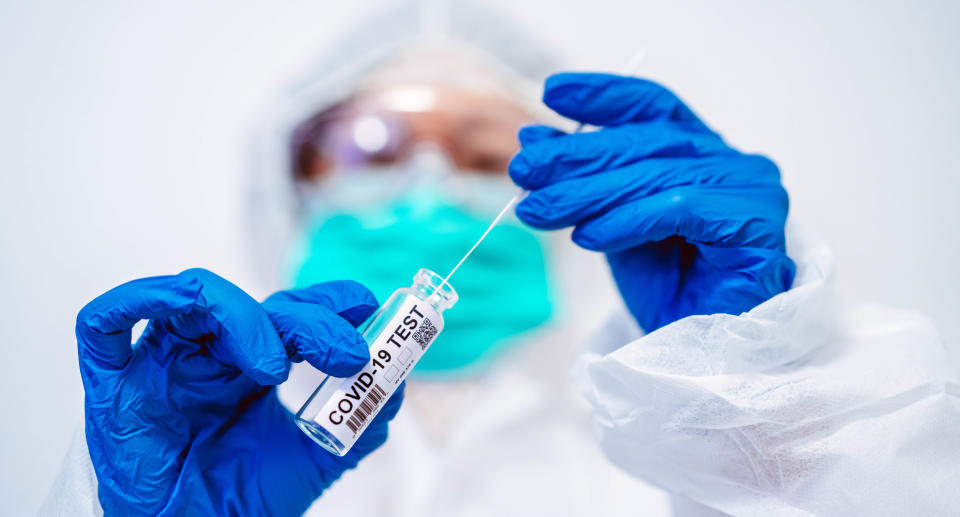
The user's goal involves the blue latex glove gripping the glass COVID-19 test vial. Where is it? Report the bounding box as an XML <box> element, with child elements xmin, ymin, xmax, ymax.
<box><xmin>77</xmin><ymin>269</ymin><xmax>402</xmax><ymax>515</ymax></box>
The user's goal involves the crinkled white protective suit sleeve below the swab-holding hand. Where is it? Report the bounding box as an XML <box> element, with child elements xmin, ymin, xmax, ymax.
<box><xmin>576</xmin><ymin>223</ymin><xmax>960</xmax><ymax>516</ymax></box>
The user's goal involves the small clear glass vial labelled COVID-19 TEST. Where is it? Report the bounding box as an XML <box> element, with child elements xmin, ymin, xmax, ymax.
<box><xmin>296</xmin><ymin>269</ymin><xmax>457</xmax><ymax>456</ymax></box>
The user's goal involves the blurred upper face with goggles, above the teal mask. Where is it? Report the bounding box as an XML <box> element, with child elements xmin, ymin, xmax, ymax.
<box><xmin>293</xmin><ymin>83</ymin><xmax>533</xmax><ymax>181</ymax></box>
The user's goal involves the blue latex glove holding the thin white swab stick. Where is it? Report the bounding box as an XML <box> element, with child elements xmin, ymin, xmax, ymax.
<box><xmin>510</xmin><ymin>73</ymin><xmax>794</xmax><ymax>332</ymax></box>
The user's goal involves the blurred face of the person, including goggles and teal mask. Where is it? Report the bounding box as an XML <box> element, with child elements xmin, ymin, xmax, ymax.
<box><xmin>293</xmin><ymin>83</ymin><xmax>552</xmax><ymax>378</ymax></box>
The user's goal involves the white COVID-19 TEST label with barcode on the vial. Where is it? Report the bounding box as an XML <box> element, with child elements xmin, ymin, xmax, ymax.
<box><xmin>314</xmin><ymin>295</ymin><xmax>443</xmax><ymax>449</ymax></box>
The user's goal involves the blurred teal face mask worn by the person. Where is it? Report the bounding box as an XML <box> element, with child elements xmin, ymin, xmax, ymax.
<box><xmin>295</xmin><ymin>177</ymin><xmax>551</xmax><ymax>376</ymax></box>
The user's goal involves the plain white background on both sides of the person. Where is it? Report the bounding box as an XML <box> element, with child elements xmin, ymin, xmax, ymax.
<box><xmin>0</xmin><ymin>0</ymin><xmax>960</xmax><ymax>515</ymax></box>
